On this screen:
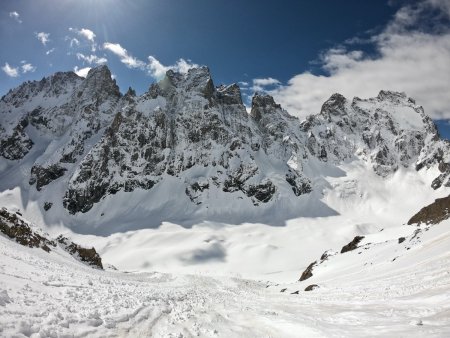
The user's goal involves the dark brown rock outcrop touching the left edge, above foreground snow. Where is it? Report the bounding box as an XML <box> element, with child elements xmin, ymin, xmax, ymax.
<box><xmin>0</xmin><ymin>208</ymin><xmax>56</xmax><ymax>252</ymax></box>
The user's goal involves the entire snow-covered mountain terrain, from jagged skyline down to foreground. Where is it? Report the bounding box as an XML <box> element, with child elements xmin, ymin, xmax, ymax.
<box><xmin>0</xmin><ymin>66</ymin><xmax>450</xmax><ymax>337</ymax></box>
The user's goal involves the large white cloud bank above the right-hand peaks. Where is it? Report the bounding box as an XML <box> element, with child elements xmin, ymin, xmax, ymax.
<box><xmin>270</xmin><ymin>0</ymin><xmax>450</xmax><ymax>119</ymax></box>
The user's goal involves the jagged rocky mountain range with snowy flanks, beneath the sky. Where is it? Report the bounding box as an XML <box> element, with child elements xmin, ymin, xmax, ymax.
<box><xmin>0</xmin><ymin>66</ymin><xmax>450</xmax><ymax>231</ymax></box>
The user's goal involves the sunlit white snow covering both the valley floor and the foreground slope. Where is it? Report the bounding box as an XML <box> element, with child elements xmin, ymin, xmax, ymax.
<box><xmin>0</xmin><ymin>164</ymin><xmax>450</xmax><ymax>337</ymax></box>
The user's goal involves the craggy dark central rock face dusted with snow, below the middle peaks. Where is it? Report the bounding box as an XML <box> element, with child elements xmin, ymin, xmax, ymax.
<box><xmin>63</xmin><ymin>68</ymin><xmax>311</xmax><ymax>213</ymax></box>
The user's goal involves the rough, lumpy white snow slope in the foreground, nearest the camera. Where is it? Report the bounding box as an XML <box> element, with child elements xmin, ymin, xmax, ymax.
<box><xmin>0</xmin><ymin>221</ymin><xmax>450</xmax><ymax>337</ymax></box>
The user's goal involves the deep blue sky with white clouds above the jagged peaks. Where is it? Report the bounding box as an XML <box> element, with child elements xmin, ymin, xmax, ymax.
<box><xmin>0</xmin><ymin>0</ymin><xmax>450</xmax><ymax>123</ymax></box>
